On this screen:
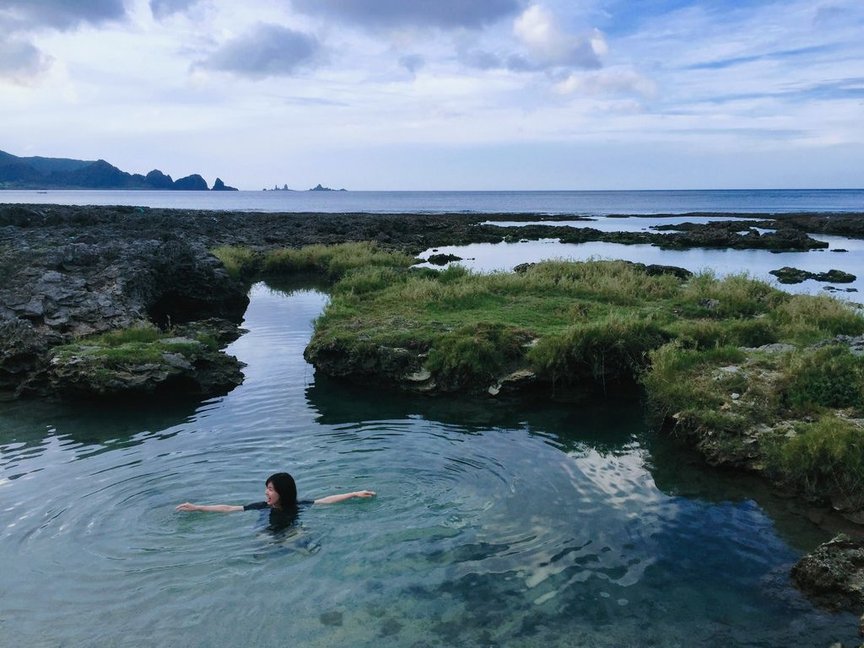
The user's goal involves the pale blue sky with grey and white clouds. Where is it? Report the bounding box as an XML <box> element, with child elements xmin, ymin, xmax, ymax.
<box><xmin>0</xmin><ymin>0</ymin><xmax>864</xmax><ymax>190</ymax></box>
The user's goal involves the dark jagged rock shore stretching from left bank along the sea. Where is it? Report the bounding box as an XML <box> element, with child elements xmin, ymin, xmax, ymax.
<box><xmin>0</xmin><ymin>204</ymin><xmax>864</xmax><ymax>398</ymax></box>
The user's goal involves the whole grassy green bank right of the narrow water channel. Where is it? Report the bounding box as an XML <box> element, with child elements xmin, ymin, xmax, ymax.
<box><xmin>300</xmin><ymin>248</ymin><xmax>864</xmax><ymax>505</ymax></box>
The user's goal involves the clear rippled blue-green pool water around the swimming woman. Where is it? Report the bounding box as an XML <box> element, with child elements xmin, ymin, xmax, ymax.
<box><xmin>0</xmin><ymin>284</ymin><xmax>857</xmax><ymax>647</ymax></box>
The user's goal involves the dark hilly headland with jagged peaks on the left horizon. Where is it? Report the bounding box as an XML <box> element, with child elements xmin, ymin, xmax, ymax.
<box><xmin>0</xmin><ymin>151</ymin><xmax>237</xmax><ymax>191</ymax></box>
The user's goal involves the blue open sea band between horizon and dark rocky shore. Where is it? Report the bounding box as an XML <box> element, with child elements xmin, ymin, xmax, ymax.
<box><xmin>0</xmin><ymin>189</ymin><xmax>864</xmax><ymax>216</ymax></box>
